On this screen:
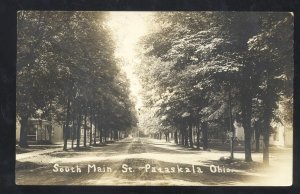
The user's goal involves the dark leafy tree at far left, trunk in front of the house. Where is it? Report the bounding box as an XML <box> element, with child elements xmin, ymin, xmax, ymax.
<box><xmin>16</xmin><ymin>12</ymin><xmax>68</xmax><ymax>147</ymax></box>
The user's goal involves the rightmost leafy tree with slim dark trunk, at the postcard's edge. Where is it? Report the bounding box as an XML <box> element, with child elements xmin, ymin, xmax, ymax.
<box><xmin>248</xmin><ymin>13</ymin><xmax>293</xmax><ymax>164</ymax></box>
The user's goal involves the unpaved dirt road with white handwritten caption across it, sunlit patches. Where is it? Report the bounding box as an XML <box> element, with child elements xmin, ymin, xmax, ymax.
<box><xmin>16</xmin><ymin>138</ymin><xmax>292</xmax><ymax>185</ymax></box>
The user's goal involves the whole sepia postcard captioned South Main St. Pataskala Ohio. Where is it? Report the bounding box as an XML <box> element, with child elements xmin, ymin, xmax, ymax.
<box><xmin>15</xmin><ymin>11</ymin><xmax>294</xmax><ymax>186</ymax></box>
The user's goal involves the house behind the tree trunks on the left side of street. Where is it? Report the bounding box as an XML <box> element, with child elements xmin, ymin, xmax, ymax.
<box><xmin>16</xmin><ymin>118</ymin><xmax>63</xmax><ymax>144</ymax></box>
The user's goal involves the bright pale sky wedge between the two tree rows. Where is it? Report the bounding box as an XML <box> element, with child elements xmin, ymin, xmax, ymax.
<box><xmin>108</xmin><ymin>12</ymin><xmax>152</xmax><ymax>109</ymax></box>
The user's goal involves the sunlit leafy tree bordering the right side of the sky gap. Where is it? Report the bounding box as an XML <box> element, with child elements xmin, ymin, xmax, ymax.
<box><xmin>138</xmin><ymin>12</ymin><xmax>239</xmax><ymax>148</ymax></box>
